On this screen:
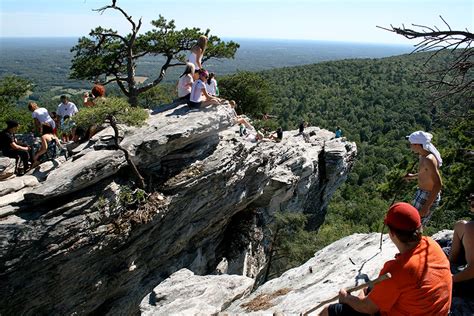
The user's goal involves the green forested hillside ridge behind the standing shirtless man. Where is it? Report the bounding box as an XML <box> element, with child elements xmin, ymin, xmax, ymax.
<box><xmin>261</xmin><ymin>52</ymin><xmax>474</xmax><ymax>266</ymax></box>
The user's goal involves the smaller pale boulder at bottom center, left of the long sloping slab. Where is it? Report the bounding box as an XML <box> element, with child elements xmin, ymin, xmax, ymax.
<box><xmin>140</xmin><ymin>269</ymin><xmax>254</xmax><ymax>316</ymax></box>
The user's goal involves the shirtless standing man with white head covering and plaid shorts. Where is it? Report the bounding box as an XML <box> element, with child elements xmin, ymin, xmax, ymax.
<box><xmin>404</xmin><ymin>131</ymin><xmax>443</xmax><ymax>226</ymax></box>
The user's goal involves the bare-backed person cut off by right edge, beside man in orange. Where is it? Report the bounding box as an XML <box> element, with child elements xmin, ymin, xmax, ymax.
<box><xmin>449</xmin><ymin>193</ymin><xmax>474</xmax><ymax>299</ymax></box>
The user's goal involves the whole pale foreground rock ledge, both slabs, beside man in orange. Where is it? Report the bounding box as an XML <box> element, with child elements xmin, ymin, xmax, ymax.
<box><xmin>140</xmin><ymin>231</ymin><xmax>474</xmax><ymax>316</ymax></box>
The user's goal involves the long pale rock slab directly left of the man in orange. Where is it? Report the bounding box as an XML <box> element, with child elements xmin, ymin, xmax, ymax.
<box><xmin>224</xmin><ymin>233</ymin><xmax>398</xmax><ymax>315</ymax></box>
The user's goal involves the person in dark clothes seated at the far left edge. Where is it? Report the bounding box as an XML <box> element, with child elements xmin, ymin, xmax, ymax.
<box><xmin>0</xmin><ymin>120</ymin><xmax>30</xmax><ymax>171</ymax></box>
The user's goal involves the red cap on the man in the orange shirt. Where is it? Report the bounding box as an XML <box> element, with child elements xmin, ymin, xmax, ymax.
<box><xmin>383</xmin><ymin>202</ymin><xmax>421</xmax><ymax>231</ymax></box>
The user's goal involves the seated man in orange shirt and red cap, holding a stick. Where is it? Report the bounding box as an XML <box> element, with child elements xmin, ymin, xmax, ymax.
<box><xmin>320</xmin><ymin>202</ymin><xmax>452</xmax><ymax>316</ymax></box>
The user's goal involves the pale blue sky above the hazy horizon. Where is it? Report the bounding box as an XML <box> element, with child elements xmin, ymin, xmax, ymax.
<box><xmin>0</xmin><ymin>0</ymin><xmax>474</xmax><ymax>45</ymax></box>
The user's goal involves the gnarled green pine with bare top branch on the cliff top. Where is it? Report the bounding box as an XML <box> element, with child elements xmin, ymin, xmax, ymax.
<box><xmin>70</xmin><ymin>1</ymin><xmax>239</xmax><ymax>106</ymax></box>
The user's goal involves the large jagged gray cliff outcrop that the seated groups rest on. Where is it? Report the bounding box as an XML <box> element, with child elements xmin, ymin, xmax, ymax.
<box><xmin>0</xmin><ymin>105</ymin><xmax>356</xmax><ymax>315</ymax></box>
